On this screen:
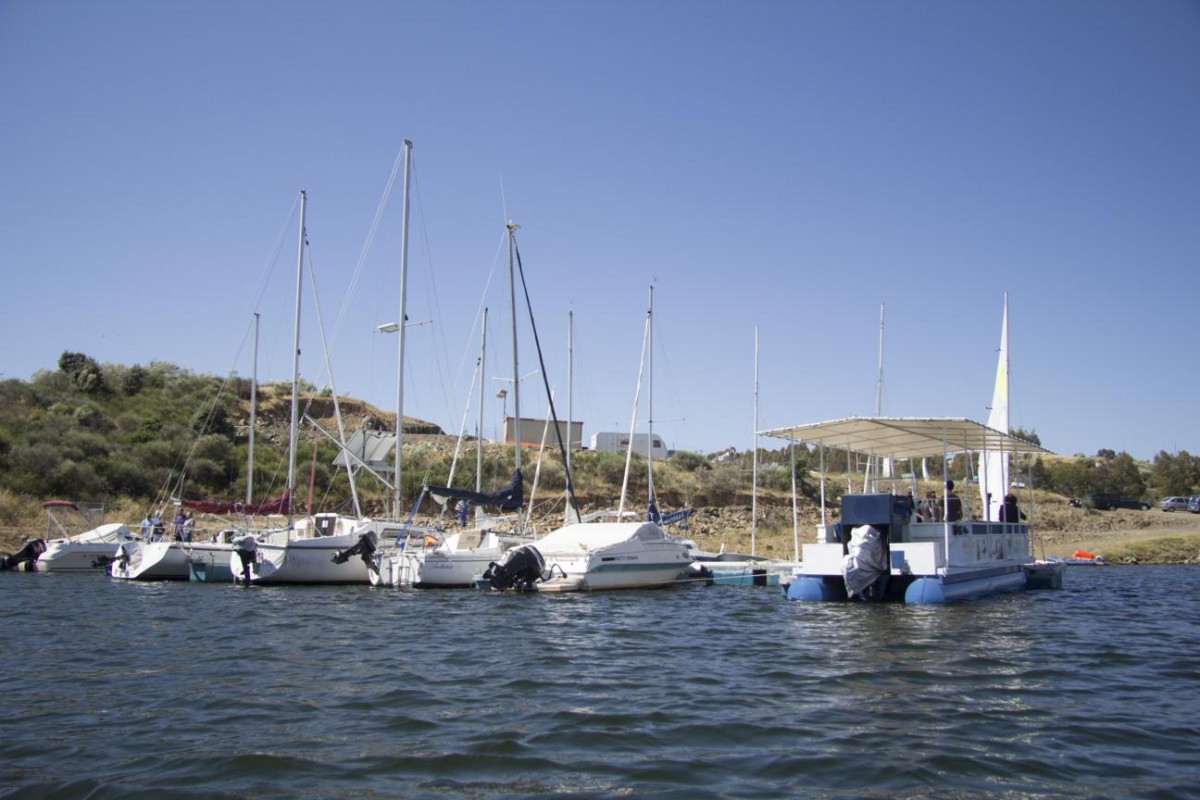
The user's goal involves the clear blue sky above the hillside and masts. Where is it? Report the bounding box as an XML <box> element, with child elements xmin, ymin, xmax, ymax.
<box><xmin>0</xmin><ymin>0</ymin><xmax>1200</xmax><ymax>458</ymax></box>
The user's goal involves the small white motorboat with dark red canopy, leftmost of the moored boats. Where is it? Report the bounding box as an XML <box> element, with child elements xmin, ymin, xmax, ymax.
<box><xmin>27</xmin><ymin>500</ymin><xmax>138</xmax><ymax>572</ymax></box>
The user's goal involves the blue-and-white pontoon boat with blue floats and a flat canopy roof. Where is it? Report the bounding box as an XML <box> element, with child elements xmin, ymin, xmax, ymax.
<box><xmin>764</xmin><ymin>297</ymin><xmax>1061</xmax><ymax>604</ymax></box>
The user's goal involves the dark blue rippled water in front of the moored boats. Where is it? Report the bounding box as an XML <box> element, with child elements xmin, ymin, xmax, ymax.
<box><xmin>0</xmin><ymin>567</ymin><xmax>1200</xmax><ymax>800</ymax></box>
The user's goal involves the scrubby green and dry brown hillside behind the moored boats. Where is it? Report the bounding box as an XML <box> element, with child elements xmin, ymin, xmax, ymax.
<box><xmin>0</xmin><ymin>354</ymin><xmax>1200</xmax><ymax>561</ymax></box>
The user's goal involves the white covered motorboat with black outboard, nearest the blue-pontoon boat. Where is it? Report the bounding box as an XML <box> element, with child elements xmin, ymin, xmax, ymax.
<box><xmin>487</xmin><ymin>522</ymin><xmax>692</xmax><ymax>591</ymax></box>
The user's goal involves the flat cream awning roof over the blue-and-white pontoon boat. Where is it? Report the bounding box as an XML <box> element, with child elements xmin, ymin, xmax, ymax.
<box><xmin>762</xmin><ymin>416</ymin><xmax>1049</xmax><ymax>458</ymax></box>
